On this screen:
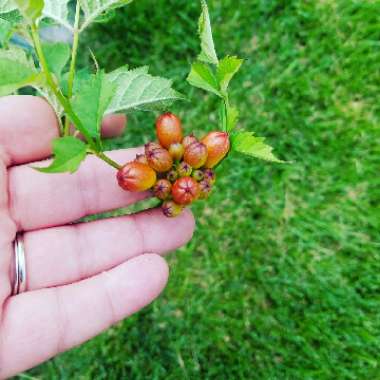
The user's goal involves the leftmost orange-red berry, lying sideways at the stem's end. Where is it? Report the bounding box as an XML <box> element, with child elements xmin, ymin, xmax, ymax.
<box><xmin>117</xmin><ymin>162</ymin><xmax>157</xmax><ymax>191</ymax></box>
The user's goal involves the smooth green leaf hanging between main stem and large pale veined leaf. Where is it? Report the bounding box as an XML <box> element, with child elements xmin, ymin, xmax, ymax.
<box><xmin>72</xmin><ymin>71</ymin><xmax>117</xmax><ymax>141</ymax></box>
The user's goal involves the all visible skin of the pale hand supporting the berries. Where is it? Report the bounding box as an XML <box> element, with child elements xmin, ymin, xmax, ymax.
<box><xmin>0</xmin><ymin>96</ymin><xmax>194</xmax><ymax>379</ymax></box>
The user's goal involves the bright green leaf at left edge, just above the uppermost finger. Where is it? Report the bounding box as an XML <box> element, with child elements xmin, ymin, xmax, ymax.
<box><xmin>0</xmin><ymin>48</ymin><xmax>39</xmax><ymax>96</ymax></box>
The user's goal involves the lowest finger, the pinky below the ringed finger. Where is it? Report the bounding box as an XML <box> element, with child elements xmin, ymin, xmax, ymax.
<box><xmin>0</xmin><ymin>255</ymin><xmax>168</xmax><ymax>378</ymax></box>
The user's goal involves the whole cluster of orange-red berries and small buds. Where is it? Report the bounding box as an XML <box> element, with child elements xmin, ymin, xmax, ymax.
<box><xmin>117</xmin><ymin>113</ymin><xmax>230</xmax><ymax>217</ymax></box>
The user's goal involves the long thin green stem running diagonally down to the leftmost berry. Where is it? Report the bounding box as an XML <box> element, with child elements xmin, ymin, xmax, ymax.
<box><xmin>31</xmin><ymin>23</ymin><xmax>121</xmax><ymax>169</ymax></box>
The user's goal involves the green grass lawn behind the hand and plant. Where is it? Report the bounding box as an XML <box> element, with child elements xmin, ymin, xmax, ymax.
<box><xmin>25</xmin><ymin>0</ymin><xmax>380</xmax><ymax>380</ymax></box>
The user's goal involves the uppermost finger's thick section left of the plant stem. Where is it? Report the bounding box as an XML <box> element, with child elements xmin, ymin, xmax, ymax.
<box><xmin>0</xmin><ymin>95</ymin><xmax>58</xmax><ymax>166</ymax></box>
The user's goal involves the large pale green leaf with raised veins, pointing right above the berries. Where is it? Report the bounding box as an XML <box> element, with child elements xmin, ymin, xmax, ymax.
<box><xmin>106</xmin><ymin>66</ymin><xmax>183</xmax><ymax>114</ymax></box>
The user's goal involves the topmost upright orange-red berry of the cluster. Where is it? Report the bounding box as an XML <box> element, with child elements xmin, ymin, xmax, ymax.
<box><xmin>156</xmin><ymin>113</ymin><xmax>183</xmax><ymax>149</ymax></box>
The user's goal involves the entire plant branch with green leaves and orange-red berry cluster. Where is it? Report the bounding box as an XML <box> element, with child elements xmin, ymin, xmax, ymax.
<box><xmin>0</xmin><ymin>0</ymin><xmax>283</xmax><ymax>217</ymax></box>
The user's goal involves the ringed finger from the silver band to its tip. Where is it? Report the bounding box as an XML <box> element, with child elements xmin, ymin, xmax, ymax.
<box><xmin>24</xmin><ymin>209</ymin><xmax>194</xmax><ymax>290</ymax></box>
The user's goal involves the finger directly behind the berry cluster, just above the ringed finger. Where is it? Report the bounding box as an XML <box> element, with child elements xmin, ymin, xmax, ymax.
<box><xmin>9</xmin><ymin>149</ymin><xmax>149</xmax><ymax>231</ymax></box>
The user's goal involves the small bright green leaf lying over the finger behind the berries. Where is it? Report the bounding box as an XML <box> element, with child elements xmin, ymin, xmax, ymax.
<box><xmin>35</xmin><ymin>136</ymin><xmax>87</xmax><ymax>173</ymax></box>
